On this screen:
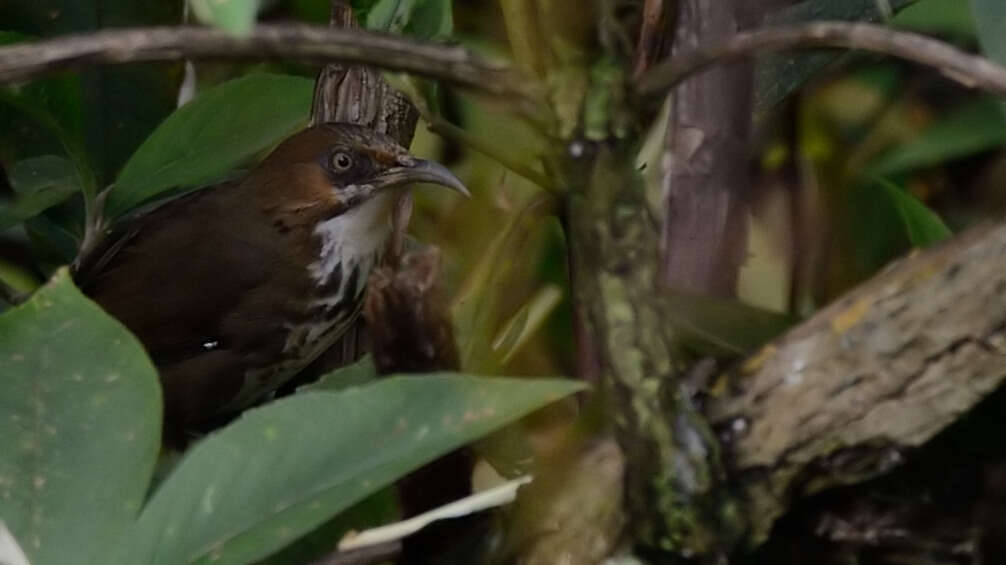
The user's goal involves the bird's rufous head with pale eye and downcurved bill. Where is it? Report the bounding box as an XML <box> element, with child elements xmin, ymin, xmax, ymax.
<box><xmin>253</xmin><ymin>124</ymin><xmax>469</xmax><ymax>219</ymax></box>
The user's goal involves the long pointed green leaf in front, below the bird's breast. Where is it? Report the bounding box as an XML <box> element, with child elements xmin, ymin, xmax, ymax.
<box><xmin>113</xmin><ymin>375</ymin><xmax>582</xmax><ymax>565</ymax></box>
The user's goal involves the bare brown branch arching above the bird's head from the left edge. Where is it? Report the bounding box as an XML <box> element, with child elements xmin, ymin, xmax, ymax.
<box><xmin>0</xmin><ymin>24</ymin><xmax>527</xmax><ymax>96</ymax></box>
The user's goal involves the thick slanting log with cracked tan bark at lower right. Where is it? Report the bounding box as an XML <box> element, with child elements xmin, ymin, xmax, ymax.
<box><xmin>707</xmin><ymin>219</ymin><xmax>1006</xmax><ymax>542</ymax></box>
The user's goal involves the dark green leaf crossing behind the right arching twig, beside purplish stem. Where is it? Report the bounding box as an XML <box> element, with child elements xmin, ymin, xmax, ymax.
<box><xmin>755</xmin><ymin>0</ymin><xmax>921</xmax><ymax>110</ymax></box>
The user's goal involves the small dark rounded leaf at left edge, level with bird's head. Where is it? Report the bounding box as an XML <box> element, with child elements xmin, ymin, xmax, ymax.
<box><xmin>0</xmin><ymin>155</ymin><xmax>80</xmax><ymax>229</ymax></box>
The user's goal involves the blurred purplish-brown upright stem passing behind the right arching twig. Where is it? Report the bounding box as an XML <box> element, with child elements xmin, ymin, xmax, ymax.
<box><xmin>661</xmin><ymin>0</ymin><xmax>751</xmax><ymax>297</ymax></box>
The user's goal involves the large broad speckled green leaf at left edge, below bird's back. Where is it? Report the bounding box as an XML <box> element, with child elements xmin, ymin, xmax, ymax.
<box><xmin>0</xmin><ymin>268</ymin><xmax>161</xmax><ymax>565</ymax></box>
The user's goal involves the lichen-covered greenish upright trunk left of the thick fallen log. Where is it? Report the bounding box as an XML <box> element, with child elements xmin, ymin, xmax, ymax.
<box><xmin>567</xmin><ymin>146</ymin><xmax>739</xmax><ymax>555</ymax></box>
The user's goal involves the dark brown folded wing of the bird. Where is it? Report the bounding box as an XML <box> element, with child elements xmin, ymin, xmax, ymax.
<box><xmin>82</xmin><ymin>183</ymin><xmax>305</xmax><ymax>365</ymax></box>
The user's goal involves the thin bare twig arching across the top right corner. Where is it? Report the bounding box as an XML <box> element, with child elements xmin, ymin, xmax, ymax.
<box><xmin>636</xmin><ymin>22</ymin><xmax>1006</xmax><ymax>99</ymax></box>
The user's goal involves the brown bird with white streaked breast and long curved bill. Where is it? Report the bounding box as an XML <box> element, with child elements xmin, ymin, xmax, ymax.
<box><xmin>78</xmin><ymin>123</ymin><xmax>469</xmax><ymax>439</ymax></box>
